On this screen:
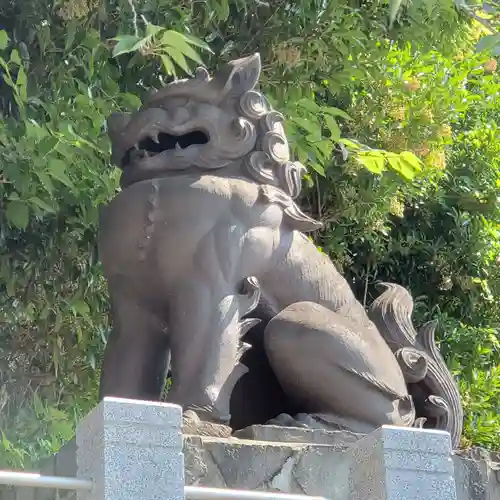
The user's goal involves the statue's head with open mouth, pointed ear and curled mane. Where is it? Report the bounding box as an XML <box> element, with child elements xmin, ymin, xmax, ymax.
<box><xmin>108</xmin><ymin>54</ymin><xmax>305</xmax><ymax>198</ymax></box>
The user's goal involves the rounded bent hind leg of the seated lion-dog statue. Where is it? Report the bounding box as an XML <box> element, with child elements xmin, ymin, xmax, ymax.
<box><xmin>264</xmin><ymin>302</ymin><xmax>415</xmax><ymax>433</ymax></box>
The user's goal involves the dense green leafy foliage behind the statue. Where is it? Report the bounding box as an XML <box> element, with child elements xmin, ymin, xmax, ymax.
<box><xmin>0</xmin><ymin>0</ymin><xmax>500</xmax><ymax>467</ymax></box>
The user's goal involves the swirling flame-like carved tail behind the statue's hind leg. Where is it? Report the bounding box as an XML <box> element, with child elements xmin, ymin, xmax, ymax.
<box><xmin>368</xmin><ymin>283</ymin><xmax>463</xmax><ymax>448</ymax></box>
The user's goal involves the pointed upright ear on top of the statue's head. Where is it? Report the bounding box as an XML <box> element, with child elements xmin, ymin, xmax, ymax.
<box><xmin>211</xmin><ymin>52</ymin><xmax>261</xmax><ymax>100</ymax></box>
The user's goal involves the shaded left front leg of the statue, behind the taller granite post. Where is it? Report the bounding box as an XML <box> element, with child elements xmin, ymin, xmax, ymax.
<box><xmin>99</xmin><ymin>280</ymin><xmax>169</xmax><ymax>401</ymax></box>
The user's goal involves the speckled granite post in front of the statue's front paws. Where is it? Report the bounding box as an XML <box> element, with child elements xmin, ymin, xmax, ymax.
<box><xmin>76</xmin><ymin>398</ymin><xmax>184</xmax><ymax>500</ymax></box>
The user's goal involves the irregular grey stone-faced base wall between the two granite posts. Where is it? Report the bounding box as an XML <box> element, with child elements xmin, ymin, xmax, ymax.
<box><xmin>184</xmin><ymin>436</ymin><xmax>346</xmax><ymax>500</ymax></box>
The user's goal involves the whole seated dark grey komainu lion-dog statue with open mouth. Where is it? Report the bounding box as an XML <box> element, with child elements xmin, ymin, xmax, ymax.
<box><xmin>99</xmin><ymin>54</ymin><xmax>462</xmax><ymax>446</ymax></box>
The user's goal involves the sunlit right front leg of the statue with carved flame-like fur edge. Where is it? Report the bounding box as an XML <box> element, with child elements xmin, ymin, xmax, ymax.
<box><xmin>167</xmin><ymin>277</ymin><xmax>256</xmax><ymax>424</ymax></box>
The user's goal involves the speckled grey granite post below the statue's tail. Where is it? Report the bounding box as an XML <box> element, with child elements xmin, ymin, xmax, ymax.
<box><xmin>348</xmin><ymin>426</ymin><xmax>457</xmax><ymax>500</ymax></box>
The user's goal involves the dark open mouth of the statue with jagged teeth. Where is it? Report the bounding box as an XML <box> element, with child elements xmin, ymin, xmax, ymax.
<box><xmin>122</xmin><ymin>130</ymin><xmax>210</xmax><ymax>167</ymax></box>
